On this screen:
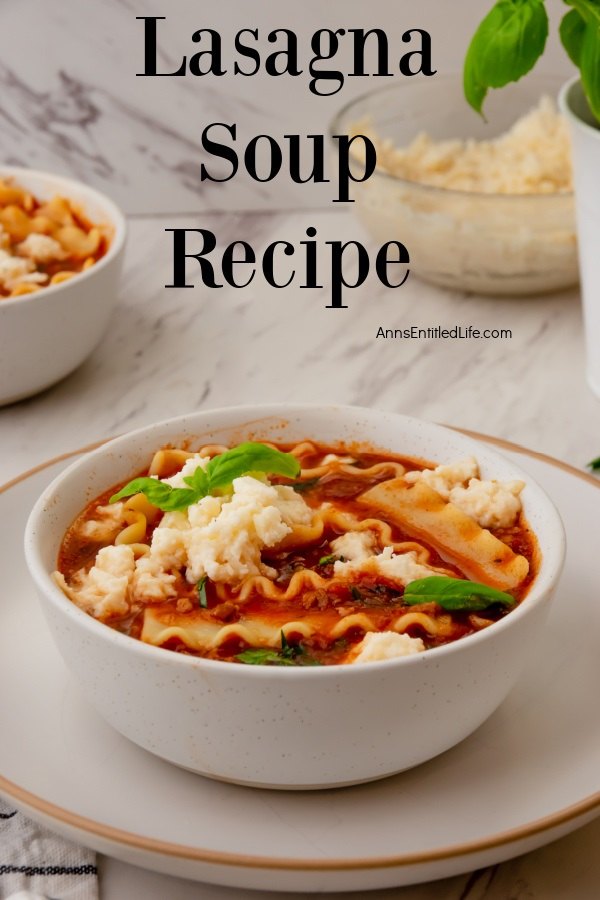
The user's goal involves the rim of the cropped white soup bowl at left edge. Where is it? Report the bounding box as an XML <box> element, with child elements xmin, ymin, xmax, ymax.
<box><xmin>0</xmin><ymin>164</ymin><xmax>127</xmax><ymax>309</ymax></box>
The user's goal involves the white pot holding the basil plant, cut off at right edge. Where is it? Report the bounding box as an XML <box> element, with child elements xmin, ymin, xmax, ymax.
<box><xmin>559</xmin><ymin>78</ymin><xmax>600</xmax><ymax>397</ymax></box>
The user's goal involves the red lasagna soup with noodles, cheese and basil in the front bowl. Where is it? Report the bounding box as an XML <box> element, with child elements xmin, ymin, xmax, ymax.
<box><xmin>54</xmin><ymin>440</ymin><xmax>537</xmax><ymax>666</ymax></box>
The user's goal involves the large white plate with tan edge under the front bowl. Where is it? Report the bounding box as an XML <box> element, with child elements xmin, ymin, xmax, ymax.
<box><xmin>0</xmin><ymin>442</ymin><xmax>600</xmax><ymax>891</ymax></box>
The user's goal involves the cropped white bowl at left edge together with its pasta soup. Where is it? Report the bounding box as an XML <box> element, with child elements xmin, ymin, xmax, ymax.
<box><xmin>0</xmin><ymin>166</ymin><xmax>126</xmax><ymax>405</ymax></box>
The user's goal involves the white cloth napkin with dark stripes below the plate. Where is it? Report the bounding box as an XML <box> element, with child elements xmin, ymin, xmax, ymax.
<box><xmin>0</xmin><ymin>800</ymin><xmax>98</xmax><ymax>900</ymax></box>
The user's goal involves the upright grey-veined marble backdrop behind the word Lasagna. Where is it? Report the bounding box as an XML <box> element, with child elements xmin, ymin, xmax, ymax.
<box><xmin>0</xmin><ymin>0</ymin><xmax>573</xmax><ymax>214</ymax></box>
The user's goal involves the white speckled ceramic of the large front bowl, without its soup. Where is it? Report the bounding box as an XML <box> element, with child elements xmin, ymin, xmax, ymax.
<box><xmin>25</xmin><ymin>405</ymin><xmax>564</xmax><ymax>788</ymax></box>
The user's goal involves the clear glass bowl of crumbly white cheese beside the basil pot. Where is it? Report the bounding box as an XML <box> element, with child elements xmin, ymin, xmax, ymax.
<box><xmin>331</xmin><ymin>76</ymin><xmax>578</xmax><ymax>295</ymax></box>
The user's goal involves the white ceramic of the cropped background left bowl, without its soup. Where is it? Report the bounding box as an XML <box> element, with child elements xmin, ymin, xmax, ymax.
<box><xmin>0</xmin><ymin>166</ymin><xmax>126</xmax><ymax>406</ymax></box>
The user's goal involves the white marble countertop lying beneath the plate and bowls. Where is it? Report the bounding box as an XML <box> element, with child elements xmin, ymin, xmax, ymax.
<box><xmin>0</xmin><ymin>210</ymin><xmax>600</xmax><ymax>900</ymax></box>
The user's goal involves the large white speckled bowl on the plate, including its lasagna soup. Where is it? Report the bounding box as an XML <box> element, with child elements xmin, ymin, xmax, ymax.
<box><xmin>25</xmin><ymin>405</ymin><xmax>564</xmax><ymax>789</ymax></box>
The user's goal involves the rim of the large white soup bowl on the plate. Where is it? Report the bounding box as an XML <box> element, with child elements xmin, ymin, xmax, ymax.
<box><xmin>24</xmin><ymin>403</ymin><xmax>566</xmax><ymax>680</ymax></box>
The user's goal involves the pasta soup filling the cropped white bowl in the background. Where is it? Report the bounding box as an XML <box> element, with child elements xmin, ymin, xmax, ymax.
<box><xmin>0</xmin><ymin>178</ymin><xmax>111</xmax><ymax>300</ymax></box>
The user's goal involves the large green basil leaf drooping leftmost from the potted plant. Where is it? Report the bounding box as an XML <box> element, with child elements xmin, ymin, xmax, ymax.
<box><xmin>463</xmin><ymin>0</ymin><xmax>548</xmax><ymax>113</ymax></box>
